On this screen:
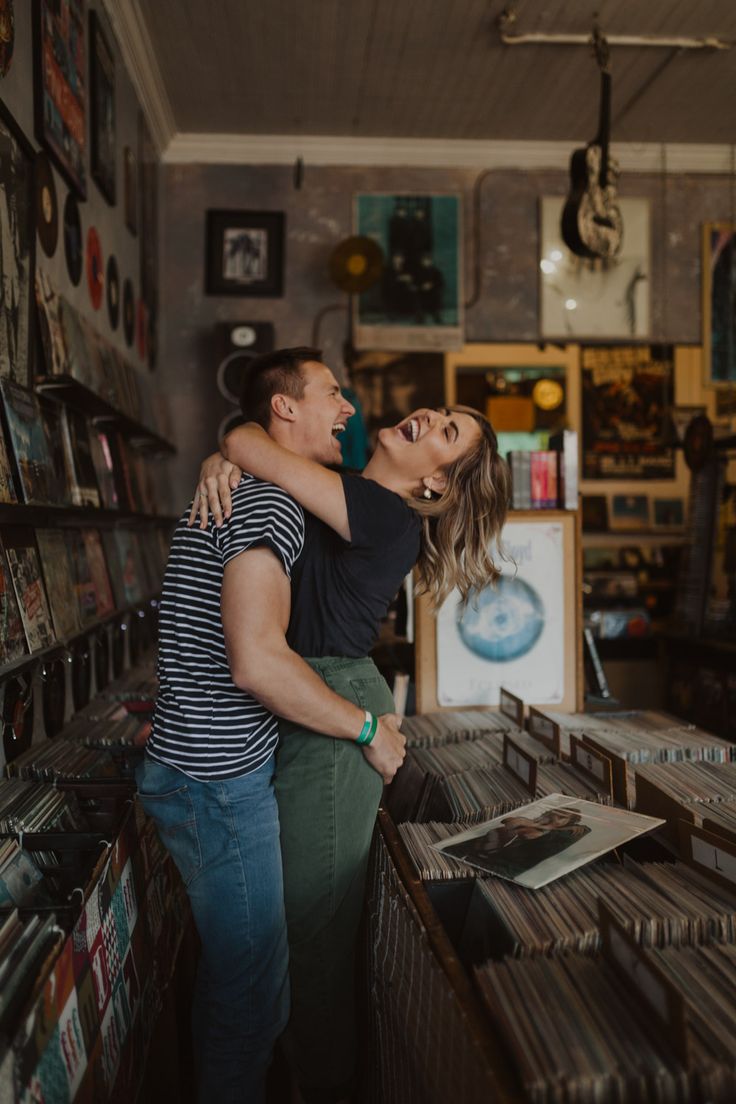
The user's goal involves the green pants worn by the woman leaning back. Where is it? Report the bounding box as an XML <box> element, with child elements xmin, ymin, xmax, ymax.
<box><xmin>274</xmin><ymin>658</ymin><xmax>394</xmax><ymax>1104</ymax></box>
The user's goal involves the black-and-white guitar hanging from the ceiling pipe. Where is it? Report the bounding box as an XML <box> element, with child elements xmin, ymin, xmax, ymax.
<box><xmin>561</xmin><ymin>36</ymin><xmax>623</xmax><ymax>259</ymax></box>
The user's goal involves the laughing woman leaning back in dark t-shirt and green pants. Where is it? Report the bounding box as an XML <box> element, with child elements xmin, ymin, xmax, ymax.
<box><xmin>191</xmin><ymin>407</ymin><xmax>509</xmax><ymax>1104</ymax></box>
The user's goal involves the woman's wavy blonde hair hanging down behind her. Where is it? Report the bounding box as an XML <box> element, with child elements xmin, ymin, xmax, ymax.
<box><xmin>409</xmin><ymin>406</ymin><xmax>511</xmax><ymax>608</ymax></box>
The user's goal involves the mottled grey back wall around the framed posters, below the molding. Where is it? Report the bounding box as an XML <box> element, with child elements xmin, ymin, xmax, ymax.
<box><xmin>157</xmin><ymin>158</ymin><xmax>734</xmax><ymax>509</ymax></box>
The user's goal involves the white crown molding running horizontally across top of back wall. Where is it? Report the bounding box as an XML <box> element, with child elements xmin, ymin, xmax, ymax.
<box><xmin>163</xmin><ymin>134</ymin><xmax>732</xmax><ymax>173</ymax></box>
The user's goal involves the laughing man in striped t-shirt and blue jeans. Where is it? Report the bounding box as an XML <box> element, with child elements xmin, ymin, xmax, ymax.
<box><xmin>138</xmin><ymin>348</ymin><xmax>404</xmax><ymax>1104</ymax></box>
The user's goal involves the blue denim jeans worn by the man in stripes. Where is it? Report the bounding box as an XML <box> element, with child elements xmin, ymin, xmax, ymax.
<box><xmin>137</xmin><ymin>756</ymin><xmax>289</xmax><ymax>1104</ymax></box>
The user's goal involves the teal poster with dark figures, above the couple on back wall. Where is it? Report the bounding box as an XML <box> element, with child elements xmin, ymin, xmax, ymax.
<box><xmin>353</xmin><ymin>194</ymin><xmax>463</xmax><ymax>350</ymax></box>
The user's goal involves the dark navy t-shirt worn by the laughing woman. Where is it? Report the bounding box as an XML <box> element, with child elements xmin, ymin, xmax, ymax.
<box><xmin>287</xmin><ymin>475</ymin><xmax>422</xmax><ymax>659</ymax></box>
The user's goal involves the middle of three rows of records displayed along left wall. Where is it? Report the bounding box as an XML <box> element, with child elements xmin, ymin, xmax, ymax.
<box><xmin>0</xmin><ymin>379</ymin><xmax>175</xmax><ymax>514</ymax></box>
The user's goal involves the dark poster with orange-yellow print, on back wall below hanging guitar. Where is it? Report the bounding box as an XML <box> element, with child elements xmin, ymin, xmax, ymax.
<box><xmin>580</xmin><ymin>344</ymin><xmax>675</xmax><ymax>479</ymax></box>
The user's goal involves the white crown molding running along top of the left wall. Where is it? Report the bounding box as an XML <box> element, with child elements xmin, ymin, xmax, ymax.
<box><xmin>103</xmin><ymin>0</ymin><xmax>177</xmax><ymax>152</ymax></box>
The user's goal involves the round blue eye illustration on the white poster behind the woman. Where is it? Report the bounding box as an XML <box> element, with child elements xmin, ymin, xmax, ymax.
<box><xmin>458</xmin><ymin>575</ymin><xmax>545</xmax><ymax>664</ymax></box>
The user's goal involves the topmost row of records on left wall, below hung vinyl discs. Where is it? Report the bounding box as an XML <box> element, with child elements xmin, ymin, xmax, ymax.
<box><xmin>35</xmin><ymin>269</ymin><xmax>175</xmax><ymax>453</ymax></box>
